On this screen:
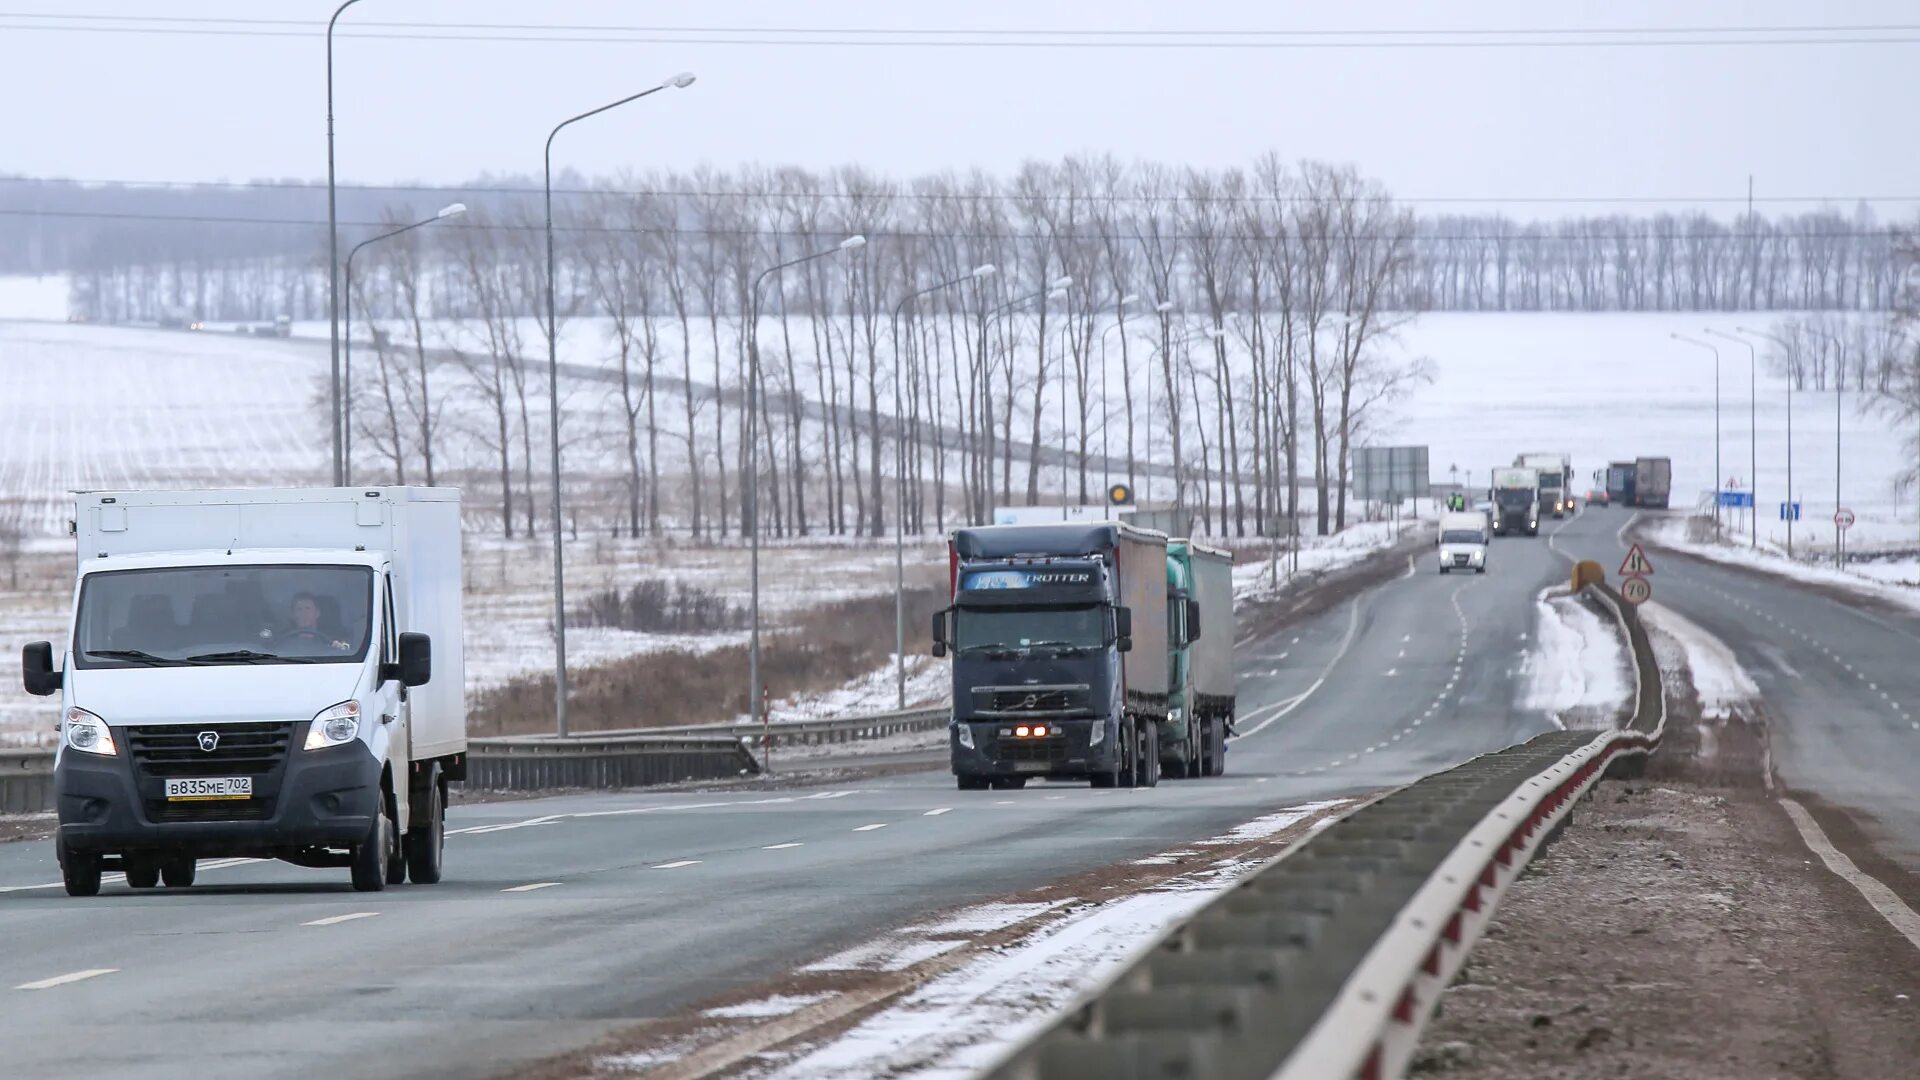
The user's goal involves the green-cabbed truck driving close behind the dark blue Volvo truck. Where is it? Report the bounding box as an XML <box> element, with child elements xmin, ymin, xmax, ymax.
<box><xmin>1160</xmin><ymin>540</ymin><xmax>1238</xmax><ymax>776</ymax></box>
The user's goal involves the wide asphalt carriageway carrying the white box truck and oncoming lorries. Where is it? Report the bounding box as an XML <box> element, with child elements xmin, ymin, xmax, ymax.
<box><xmin>0</xmin><ymin>521</ymin><xmax>1584</xmax><ymax>1080</ymax></box>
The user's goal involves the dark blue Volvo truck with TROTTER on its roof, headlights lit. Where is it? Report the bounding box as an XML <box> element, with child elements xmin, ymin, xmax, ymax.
<box><xmin>933</xmin><ymin>523</ymin><xmax>1167</xmax><ymax>790</ymax></box>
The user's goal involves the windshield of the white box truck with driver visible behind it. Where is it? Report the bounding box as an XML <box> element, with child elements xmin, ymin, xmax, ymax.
<box><xmin>73</xmin><ymin>565</ymin><xmax>372</xmax><ymax>667</ymax></box>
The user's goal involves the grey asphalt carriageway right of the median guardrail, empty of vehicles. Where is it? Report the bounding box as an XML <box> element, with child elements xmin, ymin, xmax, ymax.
<box><xmin>1559</xmin><ymin>511</ymin><xmax>1920</xmax><ymax>868</ymax></box>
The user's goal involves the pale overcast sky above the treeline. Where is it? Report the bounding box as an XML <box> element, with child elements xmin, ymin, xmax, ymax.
<box><xmin>0</xmin><ymin>0</ymin><xmax>1920</xmax><ymax>215</ymax></box>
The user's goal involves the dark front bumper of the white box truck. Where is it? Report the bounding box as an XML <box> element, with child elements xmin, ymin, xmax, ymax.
<box><xmin>54</xmin><ymin>732</ymin><xmax>380</xmax><ymax>859</ymax></box>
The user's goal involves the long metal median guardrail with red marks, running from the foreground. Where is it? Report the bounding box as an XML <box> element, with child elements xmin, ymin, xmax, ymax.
<box><xmin>989</xmin><ymin>580</ymin><xmax>1665</xmax><ymax>1080</ymax></box>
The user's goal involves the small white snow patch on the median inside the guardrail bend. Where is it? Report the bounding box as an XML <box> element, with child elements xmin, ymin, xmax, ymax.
<box><xmin>1521</xmin><ymin>590</ymin><xmax>1632</xmax><ymax>728</ymax></box>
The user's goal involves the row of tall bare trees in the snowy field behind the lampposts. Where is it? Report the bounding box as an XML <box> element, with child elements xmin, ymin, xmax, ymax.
<box><xmin>334</xmin><ymin>156</ymin><xmax>1427</xmax><ymax>536</ymax></box>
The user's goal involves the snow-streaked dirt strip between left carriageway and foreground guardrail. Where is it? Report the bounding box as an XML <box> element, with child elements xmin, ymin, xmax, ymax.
<box><xmin>564</xmin><ymin>799</ymin><xmax>1352</xmax><ymax>1080</ymax></box>
